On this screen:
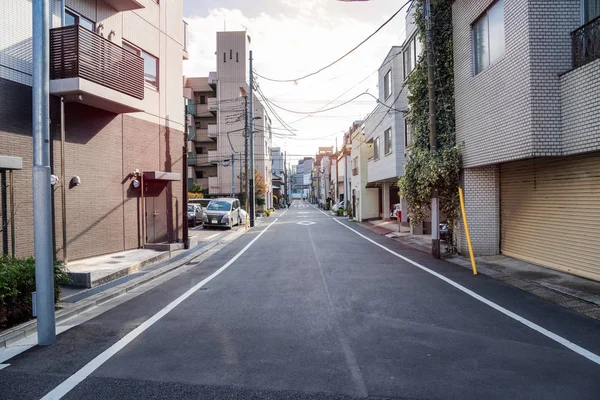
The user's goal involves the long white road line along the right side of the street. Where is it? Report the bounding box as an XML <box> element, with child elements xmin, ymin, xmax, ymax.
<box><xmin>334</xmin><ymin>219</ymin><xmax>600</xmax><ymax>365</ymax></box>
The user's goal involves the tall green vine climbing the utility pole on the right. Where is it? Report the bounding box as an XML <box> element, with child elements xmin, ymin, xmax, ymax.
<box><xmin>399</xmin><ymin>0</ymin><xmax>461</xmax><ymax>252</ymax></box>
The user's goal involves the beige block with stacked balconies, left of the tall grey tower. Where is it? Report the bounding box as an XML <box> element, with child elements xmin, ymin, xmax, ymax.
<box><xmin>183</xmin><ymin>77</ymin><xmax>218</xmax><ymax>194</ymax></box>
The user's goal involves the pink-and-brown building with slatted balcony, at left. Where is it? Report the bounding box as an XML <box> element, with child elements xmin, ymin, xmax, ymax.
<box><xmin>0</xmin><ymin>0</ymin><xmax>187</xmax><ymax>260</ymax></box>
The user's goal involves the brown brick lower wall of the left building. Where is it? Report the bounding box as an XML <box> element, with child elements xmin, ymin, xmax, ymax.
<box><xmin>0</xmin><ymin>79</ymin><xmax>184</xmax><ymax>260</ymax></box>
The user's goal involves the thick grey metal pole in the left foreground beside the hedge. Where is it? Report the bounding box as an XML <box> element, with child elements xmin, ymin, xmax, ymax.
<box><xmin>32</xmin><ymin>0</ymin><xmax>56</xmax><ymax>346</ymax></box>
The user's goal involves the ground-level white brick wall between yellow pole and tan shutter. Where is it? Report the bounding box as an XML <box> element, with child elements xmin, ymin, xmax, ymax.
<box><xmin>457</xmin><ymin>165</ymin><xmax>500</xmax><ymax>256</ymax></box>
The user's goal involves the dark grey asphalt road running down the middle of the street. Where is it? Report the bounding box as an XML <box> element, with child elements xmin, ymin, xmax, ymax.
<box><xmin>0</xmin><ymin>202</ymin><xmax>600</xmax><ymax>400</ymax></box>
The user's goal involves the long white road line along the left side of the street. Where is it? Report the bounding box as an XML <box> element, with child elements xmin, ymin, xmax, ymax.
<box><xmin>42</xmin><ymin>218</ymin><xmax>277</xmax><ymax>400</ymax></box>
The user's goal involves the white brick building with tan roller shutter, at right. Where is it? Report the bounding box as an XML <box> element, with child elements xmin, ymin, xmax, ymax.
<box><xmin>452</xmin><ymin>0</ymin><xmax>600</xmax><ymax>280</ymax></box>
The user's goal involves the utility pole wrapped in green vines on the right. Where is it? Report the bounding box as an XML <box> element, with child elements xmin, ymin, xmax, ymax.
<box><xmin>426</xmin><ymin>0</ymin><xmax>441</xmax><ymax>258</ymax></box>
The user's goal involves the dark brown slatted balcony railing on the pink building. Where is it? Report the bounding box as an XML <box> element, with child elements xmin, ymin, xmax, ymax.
<box><xmin>50</xmin><ymin>25</ymin><xmax>144</xmax><ymax>100</ymax></box>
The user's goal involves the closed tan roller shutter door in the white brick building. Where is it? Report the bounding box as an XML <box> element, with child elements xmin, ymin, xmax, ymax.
<box><xmin>501</xmin><ymin>153</ymin><xmax>600</xmax><ymax>281</ymax></box>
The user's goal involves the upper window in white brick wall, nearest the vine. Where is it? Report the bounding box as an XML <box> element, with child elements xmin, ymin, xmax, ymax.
<box><xmin>473</xmin><ymin>0</ymin><xmax>505</xmax><ymax>75</ymax></box>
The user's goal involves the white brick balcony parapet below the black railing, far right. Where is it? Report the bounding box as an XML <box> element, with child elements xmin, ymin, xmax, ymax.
<box><xmin>560</xmin><ymin>60</ymin><xmax>600</xmax><ymax>155</ymax></box>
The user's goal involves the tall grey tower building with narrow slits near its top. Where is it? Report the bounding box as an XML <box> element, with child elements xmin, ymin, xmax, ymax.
<box><xmin>196</xmin><ymin>31</ymin><xmax>273</xmax><ymax>208</ymax></box>
